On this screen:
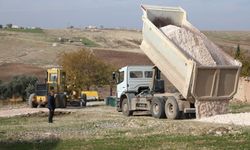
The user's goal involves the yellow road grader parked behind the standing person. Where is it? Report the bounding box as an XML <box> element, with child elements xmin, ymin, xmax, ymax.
<box><xmin>29</xmin><ymin>68</ymin><xmax>87</xmax><ymax>108</ymax></box>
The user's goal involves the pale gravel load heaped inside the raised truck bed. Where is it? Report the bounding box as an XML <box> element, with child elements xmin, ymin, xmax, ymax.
<box><xmin>160</xmin><ymin>25</ymin><xmax>235</xmax><ymax>66</ymax></box>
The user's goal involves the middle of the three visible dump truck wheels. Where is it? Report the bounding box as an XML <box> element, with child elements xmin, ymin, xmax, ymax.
<box><xmin>151</xmin><ymin>97</ymin><xmax>166</xmax><ymax>119</ymax></box>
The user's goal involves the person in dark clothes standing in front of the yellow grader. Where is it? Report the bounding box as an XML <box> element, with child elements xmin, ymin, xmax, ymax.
<box><xmin>48</xmin><ymin>87</ymin><xmax>56</xmax><ymax>123</ymax></box>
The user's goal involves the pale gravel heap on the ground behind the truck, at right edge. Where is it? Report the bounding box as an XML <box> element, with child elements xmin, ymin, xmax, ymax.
<box><xmin>197</xmin><ymin>112</ymin><xmax>250</xmax><ymax>126</ymax></box>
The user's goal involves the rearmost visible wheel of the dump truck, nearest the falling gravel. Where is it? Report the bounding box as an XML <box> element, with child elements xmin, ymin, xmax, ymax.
<box><xmin>165</xmin><ymin>97</ymin><xmax>180</xmax><ymax>119</ymax></box>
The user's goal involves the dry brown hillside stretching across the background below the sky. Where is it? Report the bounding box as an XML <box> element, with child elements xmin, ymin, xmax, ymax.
<box><xmin>0</xmin><ymin>29</ymin><xmax>250</xmax><ymax>81</ymax></box>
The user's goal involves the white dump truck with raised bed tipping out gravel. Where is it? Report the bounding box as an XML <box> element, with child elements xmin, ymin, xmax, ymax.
<box><xmin>113</xmin><ymin>5</ymin><xmax>241</xmax><ymax>119</ymax></box>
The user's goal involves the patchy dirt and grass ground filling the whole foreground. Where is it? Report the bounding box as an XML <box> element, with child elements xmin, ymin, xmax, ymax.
<box><xmin>0</xmin><ymin>102</ymin><xmax>250</xmax><ymax>149</ymax></box>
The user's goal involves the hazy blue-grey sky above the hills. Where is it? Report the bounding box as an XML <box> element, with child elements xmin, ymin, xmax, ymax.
<box><xmin>0</xmin><ymin>0</ymin><xmax>250</xmax><ymax>30</ymax></box>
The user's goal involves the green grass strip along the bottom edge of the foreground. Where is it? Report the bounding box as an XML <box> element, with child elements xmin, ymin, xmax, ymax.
<box><xmin>0</xmin><ymin>132</ymin><xmax>250</xmax><ymax>150</ymax></box>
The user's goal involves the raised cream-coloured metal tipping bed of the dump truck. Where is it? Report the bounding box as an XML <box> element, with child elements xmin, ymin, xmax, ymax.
<box><xmin>141</xmin><ymin>5</ymin><xmax>241</xmax><ymax>100</ymax></box>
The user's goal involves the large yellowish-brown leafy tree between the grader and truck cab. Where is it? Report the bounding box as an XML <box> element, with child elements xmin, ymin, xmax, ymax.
<box><xmin>59</xmin><ymin>49</ymin><xmax>113</xmax><ymax>90</ymax></box>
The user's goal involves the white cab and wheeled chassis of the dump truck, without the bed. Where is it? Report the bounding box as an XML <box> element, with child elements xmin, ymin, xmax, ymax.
<box><xmin>113</xmin><ymin>66</ymin><xmax>195</xmax><ymax>119</ymax></box>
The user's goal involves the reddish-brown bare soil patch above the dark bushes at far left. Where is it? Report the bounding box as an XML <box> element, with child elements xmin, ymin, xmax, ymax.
<box><xmin>0</xmin><ymin>63</ymin><xmax>46</xmax><ymax>82</ymax></box>
